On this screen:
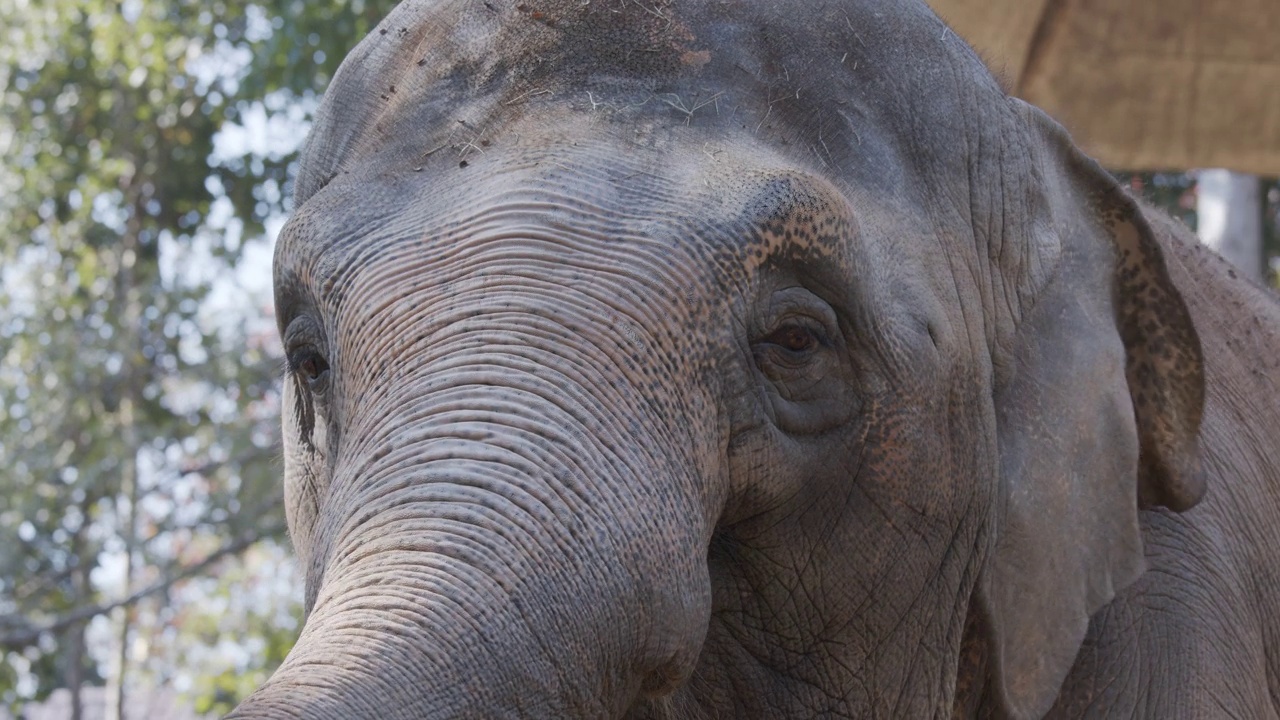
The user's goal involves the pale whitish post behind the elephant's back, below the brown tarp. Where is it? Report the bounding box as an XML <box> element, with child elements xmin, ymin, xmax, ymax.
<box><xmin>1196</xmin><ymin>170</ymin><xmax>1262</xmax><ymax>281</ymax></box>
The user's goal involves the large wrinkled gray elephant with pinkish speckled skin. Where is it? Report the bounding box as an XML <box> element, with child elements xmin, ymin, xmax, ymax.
<box><xmin>233</xmin><ymin>0</ymin><xmax>1280</xmax><ymax>720</ymax></box>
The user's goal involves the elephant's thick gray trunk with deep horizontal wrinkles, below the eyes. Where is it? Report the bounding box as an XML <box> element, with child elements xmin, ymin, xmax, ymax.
<box><xmin>230</xmin><ymin>335</ymin><xmax>710</xmax><ymax>720</ymax></box>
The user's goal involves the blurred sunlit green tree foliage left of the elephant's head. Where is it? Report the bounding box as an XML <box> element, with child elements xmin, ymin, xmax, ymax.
<box><xmin>0</xmin><ymin>0</ymin><xmax>393</xmax><ymax>712</ymax></box>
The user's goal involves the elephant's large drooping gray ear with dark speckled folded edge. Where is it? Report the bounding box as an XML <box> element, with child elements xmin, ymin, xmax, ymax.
<box><xmin>974</xmin><ymin>100</ymin><xmax>1204</xmax><ymax>717</ymax></box>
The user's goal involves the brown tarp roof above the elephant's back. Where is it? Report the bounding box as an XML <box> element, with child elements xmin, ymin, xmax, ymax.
<box><xmin>929</xmin><ymin>0</ymin><xmax>1280</xmax><ymax>176</ymax></box>
